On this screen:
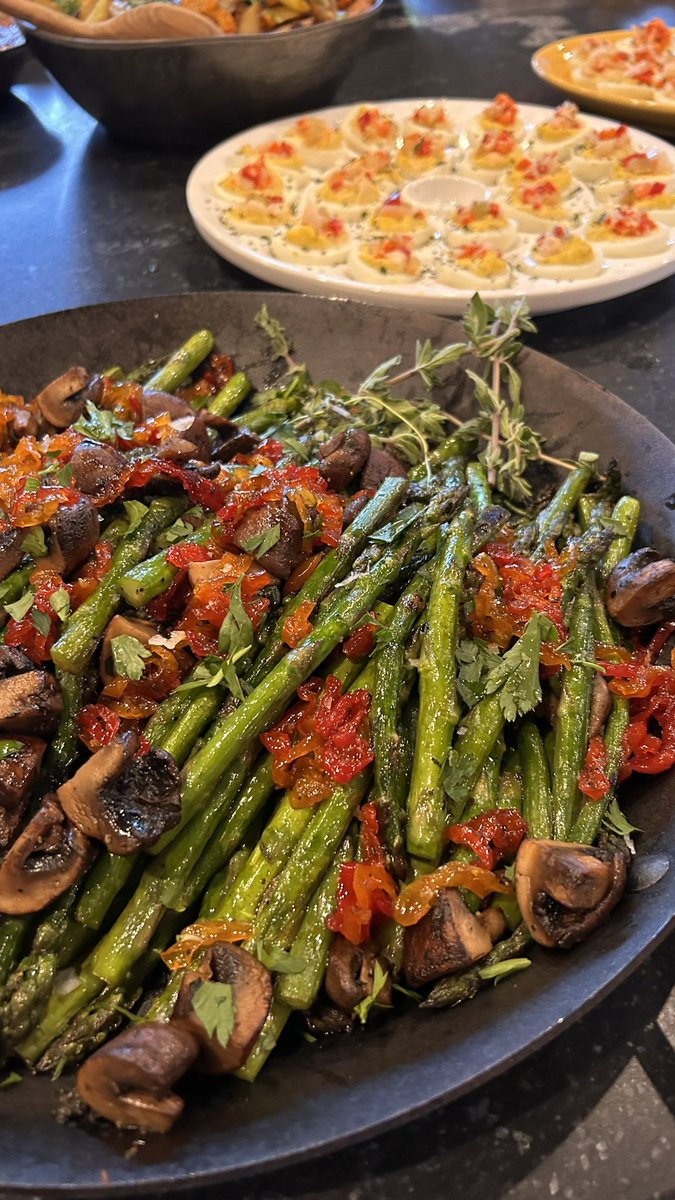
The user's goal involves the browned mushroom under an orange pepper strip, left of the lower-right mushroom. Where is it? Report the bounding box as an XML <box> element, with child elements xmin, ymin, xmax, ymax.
<box><xmin>404</xmin><ymin>888</ymin><xmax>492</xmax><ymax>988</ymax></box>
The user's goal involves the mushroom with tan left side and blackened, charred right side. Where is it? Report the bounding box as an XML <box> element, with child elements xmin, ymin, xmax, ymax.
<box><xmin>56</xmin><ymin>732</ymin><xmax>180</xmax><ymax>854</ymax></box>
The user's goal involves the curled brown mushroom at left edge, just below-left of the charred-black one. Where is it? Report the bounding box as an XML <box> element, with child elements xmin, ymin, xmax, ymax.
<box><xmin>0</xmin><ymin>796</ymin><xmax>90</xmax><ymax>916</ymax></box>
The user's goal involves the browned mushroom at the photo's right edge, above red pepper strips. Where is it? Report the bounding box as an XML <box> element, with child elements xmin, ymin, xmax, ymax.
<box><xmin>605</xmin><ymin>547</ymin><xmax>675</xmax><ymax>629</ymax></box>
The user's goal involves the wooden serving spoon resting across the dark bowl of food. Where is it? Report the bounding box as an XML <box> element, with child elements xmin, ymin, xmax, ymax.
<box><xmin>0</xmin><ymin>0</ymin><xmax>222</xmax><ymax>42</ymax></box>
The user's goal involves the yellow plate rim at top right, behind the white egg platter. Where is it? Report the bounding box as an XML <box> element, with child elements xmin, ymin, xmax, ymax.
<box><xmin>532</xmin><ymin>29</ymin><xmax>675</xmax><ymax>136</ymax></box>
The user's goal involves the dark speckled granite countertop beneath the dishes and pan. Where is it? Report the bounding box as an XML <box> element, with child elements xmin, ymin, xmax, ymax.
<box><xmin>0</xmin><ymin>0</ymin><xmax>675</xmax><ymax>1200</ymax></box>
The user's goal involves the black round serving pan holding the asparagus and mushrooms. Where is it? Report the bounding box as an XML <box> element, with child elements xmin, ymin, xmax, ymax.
<box><xmin>0</xmin><ymin>293</ymin><xmax>675</xmax><ymax>1198</ymax></box>
